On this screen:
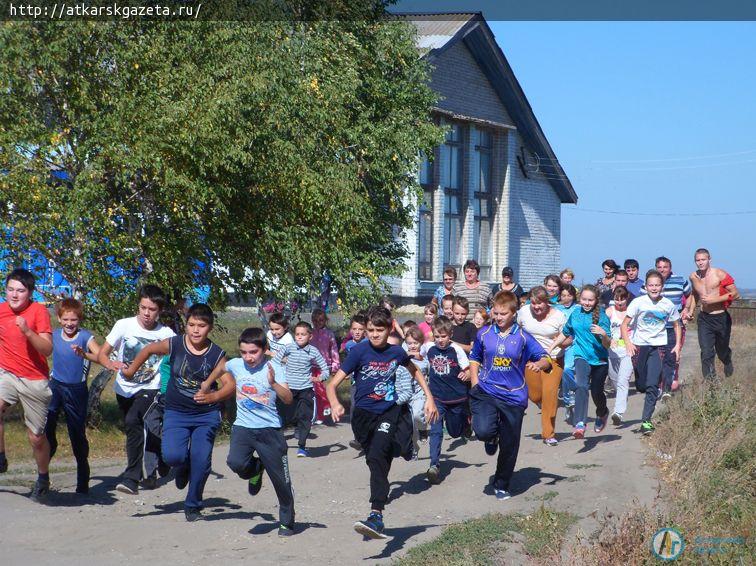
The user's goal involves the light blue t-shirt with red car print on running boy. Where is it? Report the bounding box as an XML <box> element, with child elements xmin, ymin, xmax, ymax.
<box><xmin>226</xmin><ymin>358</ymin><xmax>286</xmax><ymax>428</ymax></box>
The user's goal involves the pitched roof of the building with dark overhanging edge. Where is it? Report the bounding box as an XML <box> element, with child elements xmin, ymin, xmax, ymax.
<box><xmin>395</xmin><ymin>12</ymin><xmax>578</xmax><ymax>204</ymax></box>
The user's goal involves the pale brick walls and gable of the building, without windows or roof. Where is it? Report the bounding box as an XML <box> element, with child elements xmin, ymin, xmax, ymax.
<box><xmin>389</xmin><ymin>42</ymin><xmax>561</xmax><ymax>300</ymax></box>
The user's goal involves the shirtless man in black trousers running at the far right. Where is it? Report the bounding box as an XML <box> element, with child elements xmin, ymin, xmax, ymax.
<box><xmin>683</xmin><ymin>248</ymin><xmax>740</xmax><ymax>379</ymax></box>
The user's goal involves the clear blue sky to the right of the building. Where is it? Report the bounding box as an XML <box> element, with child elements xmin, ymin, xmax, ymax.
<box><xmin>484</xmin><ymin>21</ymin><xmax>756</xmax><ymax>288</ymax></box>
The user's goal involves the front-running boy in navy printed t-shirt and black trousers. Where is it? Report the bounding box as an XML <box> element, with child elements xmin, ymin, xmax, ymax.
<box><xmin>326</xmin><ymin>307</ymin><xmax>438</xmax><ymax>538</ymax></box>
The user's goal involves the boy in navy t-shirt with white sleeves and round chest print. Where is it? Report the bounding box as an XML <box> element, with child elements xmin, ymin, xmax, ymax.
<box><xmin>425</xmin><ymin>316</ymin><xmax>470</xmax><ymax>483</ymax></box>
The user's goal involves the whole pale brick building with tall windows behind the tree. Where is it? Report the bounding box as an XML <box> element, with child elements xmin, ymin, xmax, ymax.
<box><xmin>390</xmin><ymin>13</ymin><xmax>577</xmax><ymax>302</ymax></box>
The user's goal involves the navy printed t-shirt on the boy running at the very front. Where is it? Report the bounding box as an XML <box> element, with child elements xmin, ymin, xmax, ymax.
<box><xmin>341</xmin><ymin>340</ymin><xmax>411</xmax><ymax>415</ymax></box>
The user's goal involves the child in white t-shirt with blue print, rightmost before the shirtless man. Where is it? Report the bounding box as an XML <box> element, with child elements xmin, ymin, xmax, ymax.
<box><xmin>620</xmin><ymin>270</ymin><xmax>682</xmax><ymax>434</ymax></box>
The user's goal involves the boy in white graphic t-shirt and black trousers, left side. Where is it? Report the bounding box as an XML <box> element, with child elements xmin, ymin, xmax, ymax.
<box><xmin>97</xmin><ymin>285</ymin><xmax>175</xmax><ymax>495</ymax></box>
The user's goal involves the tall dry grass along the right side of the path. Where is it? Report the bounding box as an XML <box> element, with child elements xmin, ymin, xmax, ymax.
<box><xmin>570</xmin><ymin>326</ymin><xmax>756</xmax><ymax>566</ymax></box>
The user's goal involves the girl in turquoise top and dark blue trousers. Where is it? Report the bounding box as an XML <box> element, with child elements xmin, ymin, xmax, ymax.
<box><xmin>549</xmin><ymin>285</ymin><xmax>611</xmax><ymax>438</ymax></box>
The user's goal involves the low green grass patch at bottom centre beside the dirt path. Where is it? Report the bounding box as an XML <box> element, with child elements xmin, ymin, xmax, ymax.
<box><xmin>395</xmin><ymin>505</ymin><xmax>576</xmax><ymax>566</ymax></box>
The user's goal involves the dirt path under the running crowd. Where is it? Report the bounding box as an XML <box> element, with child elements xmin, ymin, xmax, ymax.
<box><xmin>0</xmin><ymin>335</ymin><xmax>698</xmax><ymax>566</ymax></box>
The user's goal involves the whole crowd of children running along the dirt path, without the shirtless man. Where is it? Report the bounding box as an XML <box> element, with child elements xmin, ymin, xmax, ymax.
<box><xmin>0</xmin><ymin>251</ymin><xmax>740</xmax><ymax>538</ymax></box>
